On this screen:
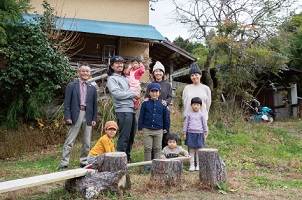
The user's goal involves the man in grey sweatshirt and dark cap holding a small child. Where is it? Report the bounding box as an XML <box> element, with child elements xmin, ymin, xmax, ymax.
<box><xmin>107</xmin><ymin>56</ymin><xmax>140</xmax><ymax>162</ymax></box>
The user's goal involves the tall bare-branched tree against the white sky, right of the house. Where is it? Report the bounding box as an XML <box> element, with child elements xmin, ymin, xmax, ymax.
<box><xmin>172</xmin><ymin>0</ymin><xmax>295</xmax><ymax>101</ymax></box>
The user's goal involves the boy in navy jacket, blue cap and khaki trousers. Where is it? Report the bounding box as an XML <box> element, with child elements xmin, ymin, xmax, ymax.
<box><xmin>138</xmin><ymin>83</ymin><xmax>170</xmax><ymax>171</ymax></box>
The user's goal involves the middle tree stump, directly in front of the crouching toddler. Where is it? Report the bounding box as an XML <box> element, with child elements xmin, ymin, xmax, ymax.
<box><xmin>151</xmin><ymin>159</ymin><xmax>183</xmax><ymax>186</ymax></box>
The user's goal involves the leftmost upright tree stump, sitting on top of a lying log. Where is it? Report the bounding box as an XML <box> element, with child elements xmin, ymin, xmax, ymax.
<box><xmin>92</xmin><ymin>152</ymin><xmax>127</xmax><ymax>172</ymax></box>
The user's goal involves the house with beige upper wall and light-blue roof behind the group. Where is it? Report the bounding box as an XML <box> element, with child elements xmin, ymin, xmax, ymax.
<box><xmin>27</xmin><ymin>0</ymin><xmax>197</xmax><ymax>81</ymax></box>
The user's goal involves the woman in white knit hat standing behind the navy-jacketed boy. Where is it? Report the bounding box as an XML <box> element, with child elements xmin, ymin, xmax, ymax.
<box><xmin>144</xmin><ymin>61</ymin><xmax>172</xmax><ymax>150</ymax></box>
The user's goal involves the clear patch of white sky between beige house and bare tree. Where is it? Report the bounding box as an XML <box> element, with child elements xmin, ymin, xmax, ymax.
<box><xmin>149</xmin><ymin>0</ymin><xmax>189</xmax><ymax>42</ymax></box>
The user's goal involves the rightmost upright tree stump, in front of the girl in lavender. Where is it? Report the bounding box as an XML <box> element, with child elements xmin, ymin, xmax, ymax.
<box><xmin>198</xmin><ymin>148</ymin><xmax>227</xmax><ymax>188</ymax></box>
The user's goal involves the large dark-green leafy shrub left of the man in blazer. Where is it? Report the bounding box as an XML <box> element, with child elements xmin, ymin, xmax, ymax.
<box><xmin>0</xmin><ymin>21</ymin><xmax>72</xmax><ymax>128</ymax></box>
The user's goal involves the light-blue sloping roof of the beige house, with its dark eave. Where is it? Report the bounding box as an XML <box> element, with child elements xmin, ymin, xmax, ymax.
<box><xmin>23</xmin><ymin>14</ymin><xmax>197</xmax><ymax>72</ymax></box>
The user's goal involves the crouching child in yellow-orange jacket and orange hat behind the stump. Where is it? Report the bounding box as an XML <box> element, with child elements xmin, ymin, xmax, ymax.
<box><xmin>87</xmin><ymin>121</ymin><xmax>118</xmax><ymax>164</ymax></box>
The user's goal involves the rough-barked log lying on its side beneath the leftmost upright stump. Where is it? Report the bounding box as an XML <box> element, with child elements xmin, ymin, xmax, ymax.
<box><xmin>77</xmin><ymin>171</ymin><xmax>131</xmax><ymax>199</ymax></box>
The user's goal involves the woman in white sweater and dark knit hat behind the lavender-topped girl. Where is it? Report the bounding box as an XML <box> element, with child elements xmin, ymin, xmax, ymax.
<box><xmin>182</xmin><ymin>63</ymin><xmax>212</xmax><ymax>120</ymax></box>
